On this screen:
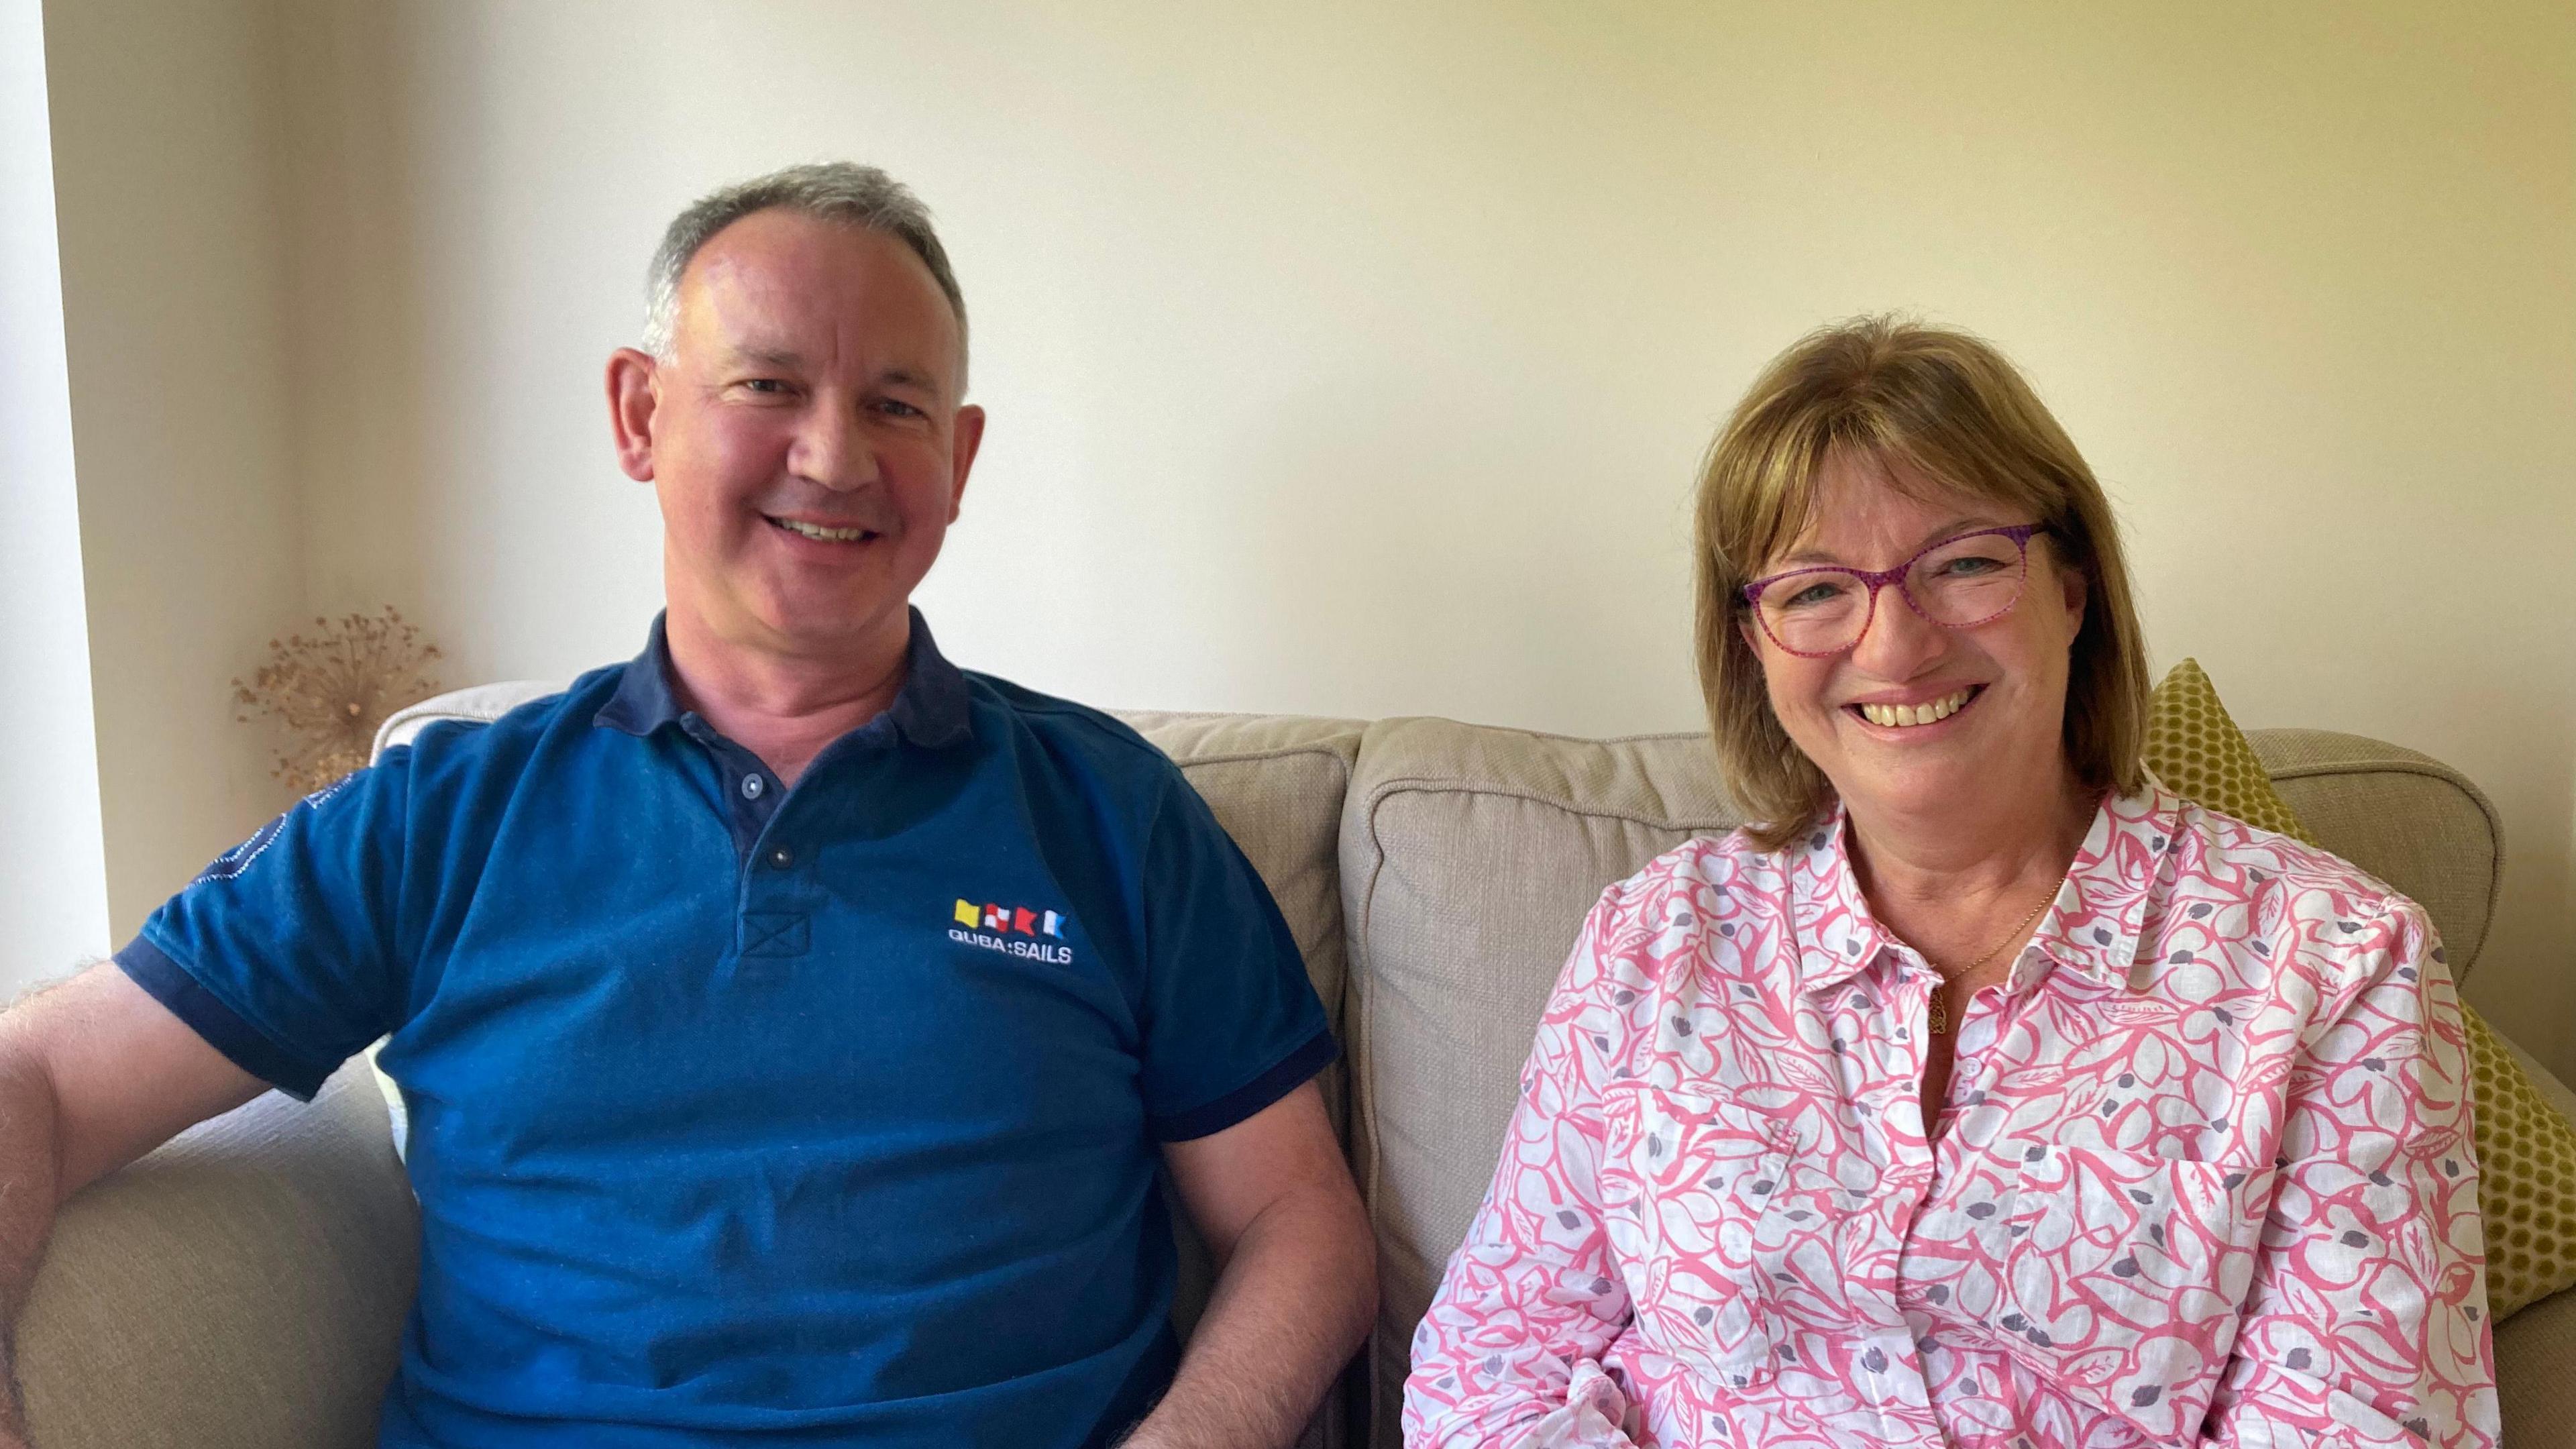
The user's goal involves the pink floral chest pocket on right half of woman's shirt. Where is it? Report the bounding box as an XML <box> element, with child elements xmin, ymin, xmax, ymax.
<box><xmin>1996</xmin><ymin>1142</ymin><xmax>2272</xmax><ymax>1439</ymax></box>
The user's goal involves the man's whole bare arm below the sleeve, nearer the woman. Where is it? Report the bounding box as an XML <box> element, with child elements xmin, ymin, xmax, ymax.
<box><xmin>1126</xmin><ymin>1083</ymin><xmax>1378</xmax><ymax>1449</ymax></box>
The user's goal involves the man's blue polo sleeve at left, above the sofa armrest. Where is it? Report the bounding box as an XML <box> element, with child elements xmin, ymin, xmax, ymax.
<box><xmin>116</xmin><ymin>748</ymin><xmax>410</xmax><ymax>1098</ymax></box>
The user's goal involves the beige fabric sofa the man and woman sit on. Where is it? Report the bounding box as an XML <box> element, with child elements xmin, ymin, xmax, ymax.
<box><xmin>21</xmin><ymin>684</ymin><xmax>2576</xmax><ymax>1449</ymax></box>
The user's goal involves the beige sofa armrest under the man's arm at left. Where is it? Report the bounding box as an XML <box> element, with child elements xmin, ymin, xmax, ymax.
<box><xmin>18</xmin><ymin>1060</ymin><xmax>420</xmax><ymax>1449</ymax></box>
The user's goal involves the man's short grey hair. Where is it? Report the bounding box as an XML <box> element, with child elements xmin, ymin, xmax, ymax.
<box><xmin>644</xmin><ymin>160</ymin><xmax>966</xmax><ymax>392</ymax></box>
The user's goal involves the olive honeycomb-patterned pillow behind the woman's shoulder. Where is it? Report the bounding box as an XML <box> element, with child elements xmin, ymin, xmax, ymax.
<box><xmin>2146</xmin><ymin>660</ymin><xmax>2576</xmax><ymax>1320</ymax></box>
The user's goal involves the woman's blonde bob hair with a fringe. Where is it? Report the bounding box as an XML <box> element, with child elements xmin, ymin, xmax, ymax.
<box><xmin>1698</xmin><ymin>317</ymin><xmax>2149</xmax><ymax>851</ymax></box>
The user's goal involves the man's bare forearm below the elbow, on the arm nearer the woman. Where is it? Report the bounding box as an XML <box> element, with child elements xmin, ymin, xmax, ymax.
<box><xmin>1123</xmin><ymin>1194</ymin><xmax>1378</xmax><ymax>1449</ymax></box>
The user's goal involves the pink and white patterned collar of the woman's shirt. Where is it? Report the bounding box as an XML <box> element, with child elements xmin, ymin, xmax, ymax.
<box><xmin>1788</xmin><ymin>789</ymin><xmax>2182</xmax><ymax>993</ymax></box>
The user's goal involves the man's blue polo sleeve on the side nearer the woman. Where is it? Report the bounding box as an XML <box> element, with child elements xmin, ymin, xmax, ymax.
<box><xmin>1144</xmin><ymin>771</ymin><xmax>1340</xmax><ymax>1142</ymax></box>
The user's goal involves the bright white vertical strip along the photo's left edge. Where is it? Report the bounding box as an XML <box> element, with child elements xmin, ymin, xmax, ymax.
<box><xmin>0</xmin><ymin>0</ymin><xmax>108</xmax><ymax>979</ymax></box>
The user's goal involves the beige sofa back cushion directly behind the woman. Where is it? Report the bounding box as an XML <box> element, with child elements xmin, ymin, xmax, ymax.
<box><xmin>1342</xmin><ymin>719</ymin><xmax>2496</xmax><ymax>1446</ymax></box>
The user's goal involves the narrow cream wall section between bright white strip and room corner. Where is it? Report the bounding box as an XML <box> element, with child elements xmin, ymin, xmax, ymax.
<box><xmin>41</xmin><ymin>0</ymin><xmax>304</xmax><ymax>938</ymax></box>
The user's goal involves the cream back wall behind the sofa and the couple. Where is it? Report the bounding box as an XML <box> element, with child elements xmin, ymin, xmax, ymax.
<box><xmin>56</xmin><ymin>0</ymin><xmax>2576</xmax><ymax>1070</ymax></box>
